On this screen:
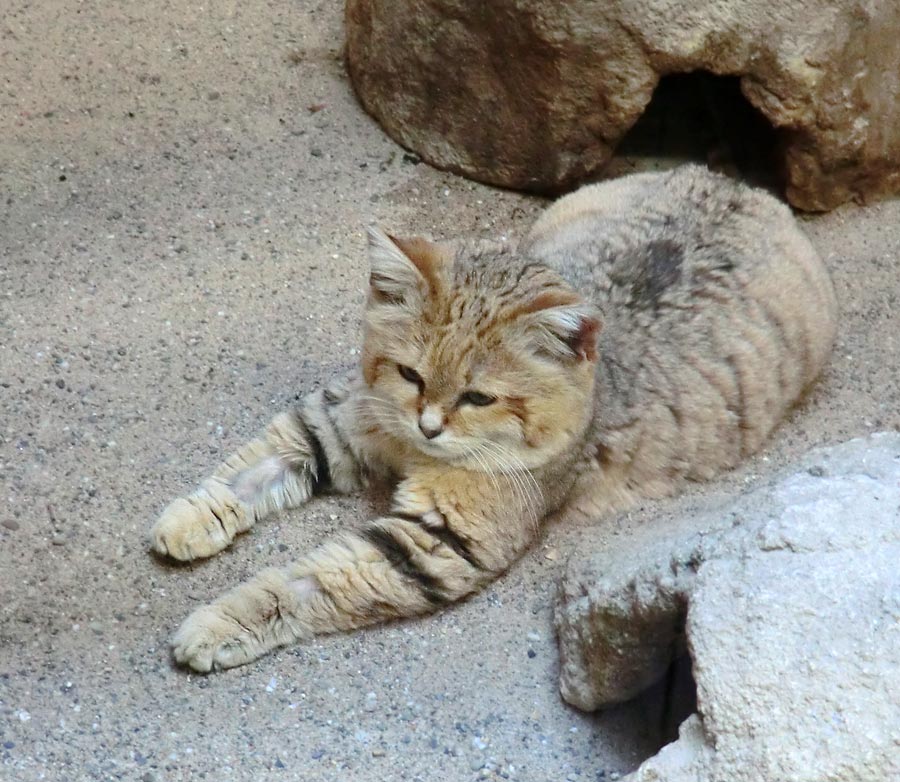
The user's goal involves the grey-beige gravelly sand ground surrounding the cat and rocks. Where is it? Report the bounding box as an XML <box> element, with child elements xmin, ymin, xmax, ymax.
<box><xmin>0</xmin><ymin>0</ymin><xmax>900</xmax><ymax>782</ymax></box>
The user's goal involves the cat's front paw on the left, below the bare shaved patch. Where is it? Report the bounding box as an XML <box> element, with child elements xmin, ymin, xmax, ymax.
<box><xmin>150</xmin><ymin>485</ymin><xmax>246</xmax><ymax>562</ymax></box>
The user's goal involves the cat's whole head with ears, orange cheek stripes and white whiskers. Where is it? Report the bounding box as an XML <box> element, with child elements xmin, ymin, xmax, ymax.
<box><xmin>363</xmin><ymin>231</ymin><xmax>600</xmax><ymax>472</ymax></box>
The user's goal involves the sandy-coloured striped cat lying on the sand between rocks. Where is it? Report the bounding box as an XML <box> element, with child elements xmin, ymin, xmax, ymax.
<box><xmin>151</xmin><ymin>166</ymin><xmax>836</xmax><ymax>672</ymax></box>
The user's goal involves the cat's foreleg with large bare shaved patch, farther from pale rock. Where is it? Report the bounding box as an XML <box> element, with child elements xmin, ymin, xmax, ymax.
<box><xmin>150</xmin><ymin>385</ymin><xmax>359</xmax><ymax>561</ymax></box>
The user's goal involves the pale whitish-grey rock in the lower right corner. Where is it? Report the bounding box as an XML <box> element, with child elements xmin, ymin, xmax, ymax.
<box><xmin>556</xmin><ymin>433</ymin><xmax>900</xmax><ymax>782</ymax></box>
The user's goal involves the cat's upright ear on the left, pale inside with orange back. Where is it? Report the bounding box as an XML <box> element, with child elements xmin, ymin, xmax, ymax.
<box><xmin>367</xmin><ymin>226</ymin><xmax>444</xmax><ymax>304</ymax></box>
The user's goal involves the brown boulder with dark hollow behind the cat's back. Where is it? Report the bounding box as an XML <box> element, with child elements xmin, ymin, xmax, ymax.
<box><xmin>346</xmin><ymin>0</ymin><xmax>900</xmax><ymax>210</ymax></box>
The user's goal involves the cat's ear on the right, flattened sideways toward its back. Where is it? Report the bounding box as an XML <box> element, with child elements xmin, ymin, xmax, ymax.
<box><xmin>528</xmin><ymin>296</ymin><xmax>603</xmax><ymax>361</ymax></box>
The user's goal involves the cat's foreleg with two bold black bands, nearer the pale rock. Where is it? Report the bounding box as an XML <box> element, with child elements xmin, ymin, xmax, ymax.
<box><xmin>173</xmin><ymin>474</ymin><xmax>538</xmax><ymax>671</ymax></box>
